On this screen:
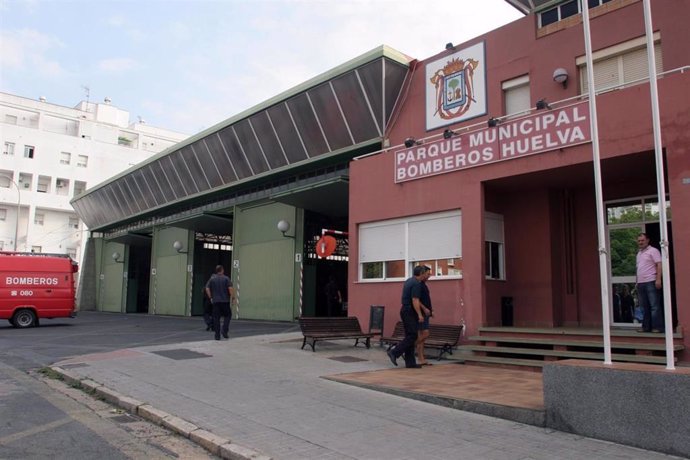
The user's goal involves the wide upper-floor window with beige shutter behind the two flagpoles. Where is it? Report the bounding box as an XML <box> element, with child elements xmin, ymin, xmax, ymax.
<box><xmin>576</xmin><ymin>33</ymin><xmax>663</xmax><ymax>93</ymax></box>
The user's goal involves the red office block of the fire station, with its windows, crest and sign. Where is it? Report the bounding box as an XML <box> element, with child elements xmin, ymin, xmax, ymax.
<box><xmin>349</xmin><ymin>0</ymin><xmax>690</xmax><ymax>362</ymax></box>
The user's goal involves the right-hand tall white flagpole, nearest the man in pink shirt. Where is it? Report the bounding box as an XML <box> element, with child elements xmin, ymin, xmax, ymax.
<box><xmin>644</xmin><ymin>0</ymin><xmax>675</xmax><ymax>370</ymax></box>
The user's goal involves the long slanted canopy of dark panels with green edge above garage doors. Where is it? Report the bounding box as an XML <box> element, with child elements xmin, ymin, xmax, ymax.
<box><xmin>72</xmin><ymin>46</ymin><xmax>410</xmax><ymax>230</ymax></box>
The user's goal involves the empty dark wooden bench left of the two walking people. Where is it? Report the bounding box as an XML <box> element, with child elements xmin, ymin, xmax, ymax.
<box><xmin>299</xmin><ymin>316</ymin><xmax>375</xmax><ymax>351</ymax></box>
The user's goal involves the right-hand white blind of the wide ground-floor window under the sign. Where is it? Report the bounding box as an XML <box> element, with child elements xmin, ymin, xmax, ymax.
<box><xmin>408</xmin><ymin>214</ymin><xmax>462</xmax><ymax>261</ymax></box>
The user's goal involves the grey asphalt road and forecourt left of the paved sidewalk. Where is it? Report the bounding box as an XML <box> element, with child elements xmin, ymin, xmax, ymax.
<box><xmin>0</xmin><ymin>312</ymin><xmax>299</xmax><ymax>459</ymax></box>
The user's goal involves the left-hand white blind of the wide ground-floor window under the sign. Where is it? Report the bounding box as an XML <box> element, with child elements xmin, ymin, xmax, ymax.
<box><xmin>359</xmin><ymin>222</ymin><xmax>405</xmax><ymax>263</ymax></box>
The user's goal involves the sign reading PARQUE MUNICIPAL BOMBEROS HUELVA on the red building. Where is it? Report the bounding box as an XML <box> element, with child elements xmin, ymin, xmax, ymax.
<box><xmin>395</xmin><ymin>102</ymin><xmax>591</xmax><ymax>182</ymax></box>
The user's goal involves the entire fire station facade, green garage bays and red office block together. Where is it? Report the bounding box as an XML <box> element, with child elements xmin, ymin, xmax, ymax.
<box><xmin>72</xmin><ymin>0</ymin><xmax>690</xmax><ymax>358</ymax></box>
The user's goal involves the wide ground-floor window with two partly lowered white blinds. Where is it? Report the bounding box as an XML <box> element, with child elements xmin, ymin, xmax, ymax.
<box><xmin>359</xmin><ymin>211</ymin><xmax>462</xmax><ymax>281</ymax></box>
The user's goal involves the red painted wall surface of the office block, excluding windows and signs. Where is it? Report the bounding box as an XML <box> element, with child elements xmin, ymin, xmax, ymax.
<box><xmin>349</xmin><ymin>1</ymin><xmax>690</xmax><ymax>358</ymax></box>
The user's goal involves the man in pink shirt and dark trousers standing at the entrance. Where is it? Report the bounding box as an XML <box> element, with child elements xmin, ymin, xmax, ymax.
<box><xmin>635</xmin><ymin>233</ymin><xmax>664</xmax><ymax>332</ymax></box>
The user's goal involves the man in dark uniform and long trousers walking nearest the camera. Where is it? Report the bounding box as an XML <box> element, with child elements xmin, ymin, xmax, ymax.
<box><xmin>387</xmin><ymin>265</ymin><xmax>429</xmax><ymax>368</ymax></box>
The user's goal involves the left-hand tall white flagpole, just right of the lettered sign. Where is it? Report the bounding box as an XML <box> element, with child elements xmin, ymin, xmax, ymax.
<box><xmin>580</xmin><ymin>0</ymin><xmax>611</xmax><ymax>364</ymax></box>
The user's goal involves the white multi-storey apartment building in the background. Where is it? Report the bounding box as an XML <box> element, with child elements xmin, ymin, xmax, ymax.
<box><xmin>0</xmin><ymin>93</ymin><xmax>188</xmax><ymax>261</ymax></box>
